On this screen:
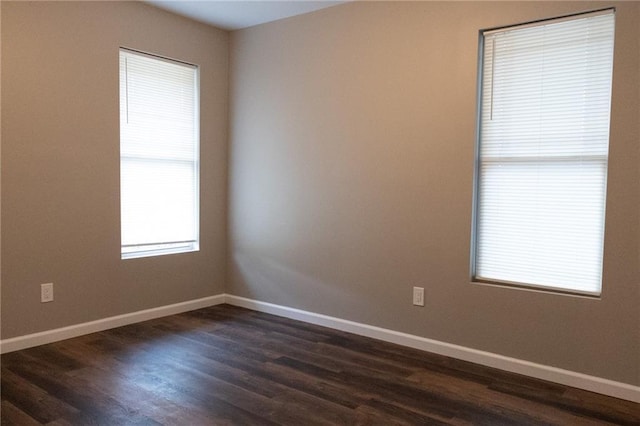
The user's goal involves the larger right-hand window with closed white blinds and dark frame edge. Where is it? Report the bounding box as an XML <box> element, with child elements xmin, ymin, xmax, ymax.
<box><xmin>472</xmin><ymin>9</ymin><xmax>614</xmax><ymax>295</ymax></box>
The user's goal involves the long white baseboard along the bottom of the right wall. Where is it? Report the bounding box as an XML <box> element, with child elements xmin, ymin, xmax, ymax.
<box><xmin>225</xmin><ymin>294</ymin><xmax>640</xmax><ymax>403</ymax></box>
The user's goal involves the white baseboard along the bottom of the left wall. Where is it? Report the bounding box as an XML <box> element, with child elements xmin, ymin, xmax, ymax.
<box><xmin>0</xmin><ymin>294</ymin><xmax>225</xmax><ymax>354</ymax></box>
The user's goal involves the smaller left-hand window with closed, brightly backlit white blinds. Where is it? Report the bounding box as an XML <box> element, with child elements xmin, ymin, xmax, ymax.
<box><xmin>120</xmin><ymin>49</ymin><xmax>199</xmax><ymax>259</ymax></box>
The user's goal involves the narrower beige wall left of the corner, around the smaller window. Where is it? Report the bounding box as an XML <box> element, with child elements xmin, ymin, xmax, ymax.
<box><xmin>2</xmin><ymin>2</ymin><xmax>229</xmax><ymax>339</ymax></box>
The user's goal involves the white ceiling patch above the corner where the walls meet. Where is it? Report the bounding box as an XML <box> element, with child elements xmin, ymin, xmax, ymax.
<box><xmin>147</xmin><ymin>0</ymin><xmax>349</xmax><ymax>30</ymax></box>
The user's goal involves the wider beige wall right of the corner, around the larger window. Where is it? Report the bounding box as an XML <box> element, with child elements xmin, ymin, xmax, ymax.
<box><xmin>227</xmin><ymin>2</ymin><xmax>640</xmax><ymax>385</ymax></box>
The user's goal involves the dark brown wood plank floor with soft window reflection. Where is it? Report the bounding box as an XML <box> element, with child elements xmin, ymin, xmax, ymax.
<box><xmin>1</xmin><ymin>305</ymin><xmax>640</xmax><ymax>426</ymax></box>
